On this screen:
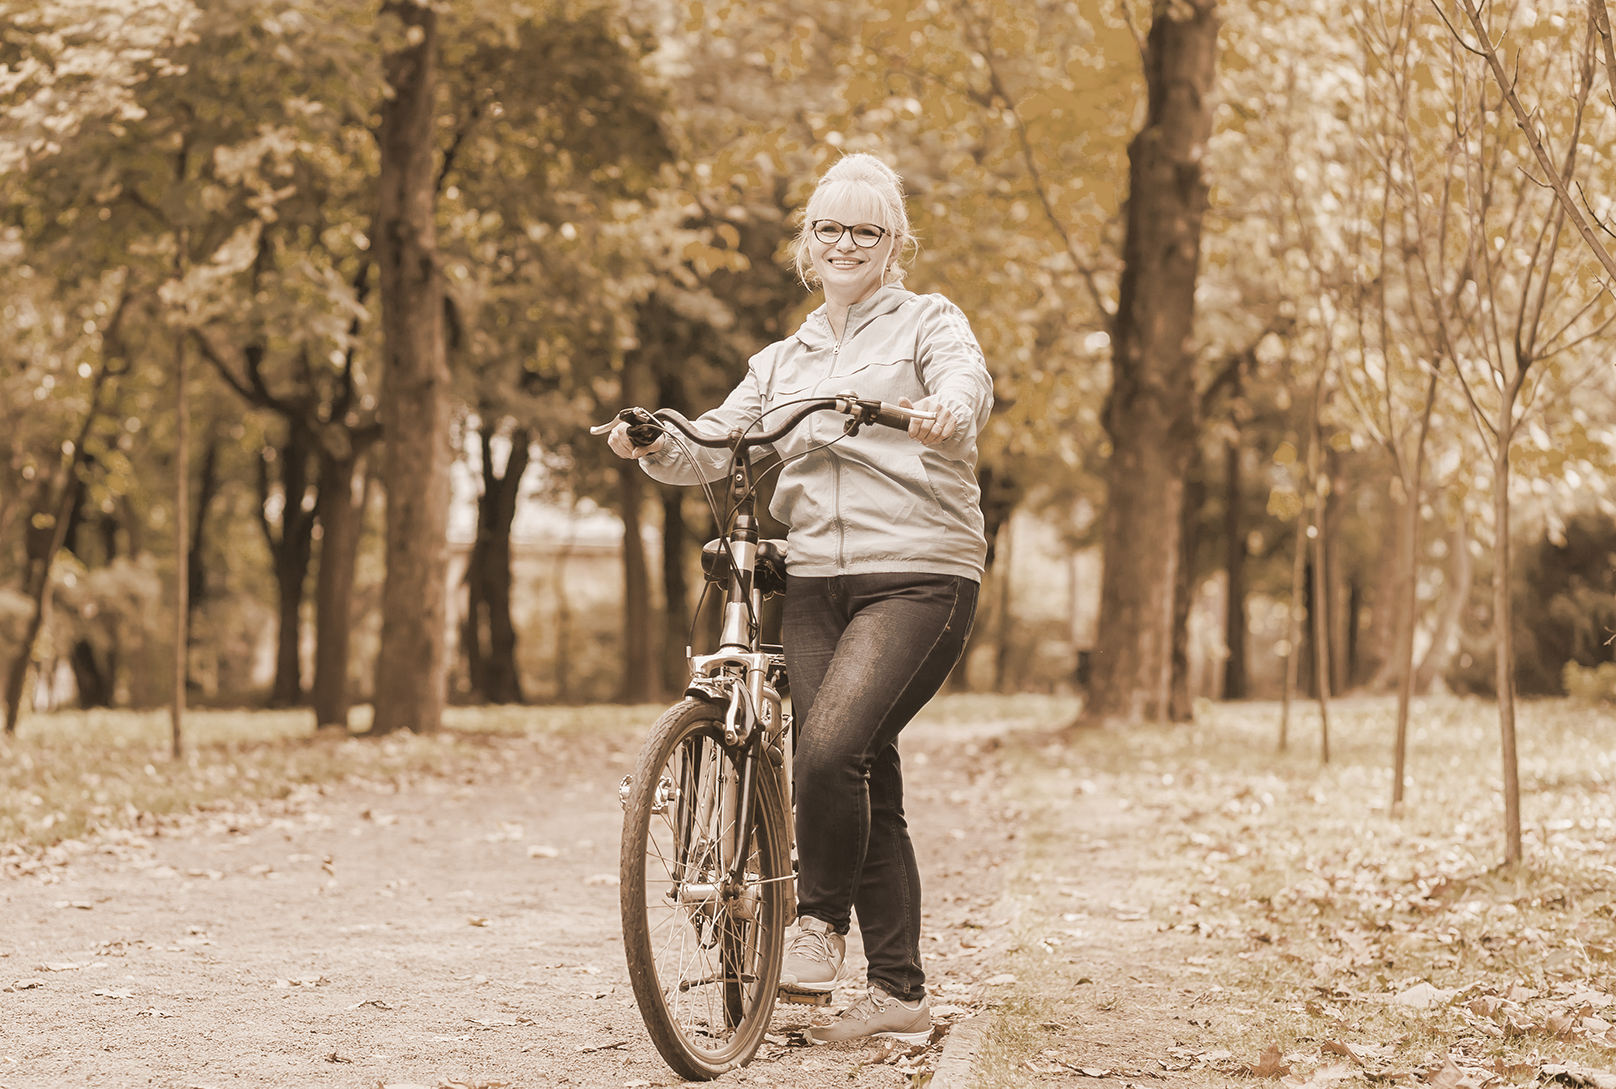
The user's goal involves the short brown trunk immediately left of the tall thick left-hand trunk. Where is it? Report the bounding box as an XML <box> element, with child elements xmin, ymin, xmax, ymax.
<box><xmin>309</xmin><ymin>446</ymin><xmax>365</xmax><ymax>729</ymax></box>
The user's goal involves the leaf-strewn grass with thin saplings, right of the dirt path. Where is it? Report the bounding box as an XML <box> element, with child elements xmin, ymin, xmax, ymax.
<box><xmin>978</xmin><ymin>700</ymin><xmax>1616</xmax><ymax>1087</ymax></box>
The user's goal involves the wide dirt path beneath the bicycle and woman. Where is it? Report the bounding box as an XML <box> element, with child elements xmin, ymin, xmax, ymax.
<box><xmin>0</xmin><ymin>725</ymin><xmax>1016</xmax><ymax>1089</ymax></box>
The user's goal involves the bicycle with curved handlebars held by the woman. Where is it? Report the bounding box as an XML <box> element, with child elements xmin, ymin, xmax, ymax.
<box><xmin>591</xmin><ymin>391</ymin><xmax>936</xmax><ymax>1081</ymax></box>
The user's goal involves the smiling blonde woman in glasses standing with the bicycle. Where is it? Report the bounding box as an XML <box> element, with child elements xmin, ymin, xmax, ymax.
<box><xmin>609</xmin><ymin>155</ymin><xmax>992</xmax><ymax>1044</ymax></box>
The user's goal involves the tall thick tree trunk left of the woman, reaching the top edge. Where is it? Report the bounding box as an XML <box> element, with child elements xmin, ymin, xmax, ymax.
<box><xmin>370</xmin><ymin>0</ymin><xmax>452</xmax><ymax>735</ymax></box>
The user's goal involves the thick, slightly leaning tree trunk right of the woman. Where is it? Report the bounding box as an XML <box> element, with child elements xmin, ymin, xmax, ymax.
<box><xmin>1089</xmin><ymin>0</ymin><xmax>1218</xmax><ymax>722</ymax></box>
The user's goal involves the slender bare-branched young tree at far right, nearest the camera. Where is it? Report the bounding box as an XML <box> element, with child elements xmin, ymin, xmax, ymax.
<box><xmin>1440</xmin><ymin>0</ymin><xmax>1616</xmax><ymax>864</ymax></box>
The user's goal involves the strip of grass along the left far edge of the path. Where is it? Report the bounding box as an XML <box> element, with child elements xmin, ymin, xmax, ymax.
<box><xmin>0</xmin><ymin>694</ymin><xmax>658</xmax><ymax>850</ymax></box>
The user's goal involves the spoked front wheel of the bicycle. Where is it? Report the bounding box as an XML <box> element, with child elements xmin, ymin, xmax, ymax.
<box><xmin>621</xmin><ymin>700</ymin><xmax>795</xmax><ymax>1081</ymax></box>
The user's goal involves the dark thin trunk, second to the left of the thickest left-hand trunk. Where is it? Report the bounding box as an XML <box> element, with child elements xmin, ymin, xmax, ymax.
<box><xmin>258</xmin><ymin>417</ymin><xmax>315</xmax><ymax>708</ymax></box>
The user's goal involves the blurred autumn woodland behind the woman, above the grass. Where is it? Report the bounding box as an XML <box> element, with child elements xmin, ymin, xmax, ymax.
<box><xmin>0</xmin><ymin>0</ymin><xmax>1616</xmax><ymax>729</ymax></box>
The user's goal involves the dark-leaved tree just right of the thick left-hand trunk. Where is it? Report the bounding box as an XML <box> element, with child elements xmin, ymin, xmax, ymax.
<box><xmin>438</xmin><ymin>5</ymin><xmax>675</xmax><ymax>701</ymax></box>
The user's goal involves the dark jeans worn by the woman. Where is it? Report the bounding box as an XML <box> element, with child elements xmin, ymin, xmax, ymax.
<box><xmin>784</xmin><ymin>574</ymin><xmax>978</xmax><ymax>1002</ymax></box>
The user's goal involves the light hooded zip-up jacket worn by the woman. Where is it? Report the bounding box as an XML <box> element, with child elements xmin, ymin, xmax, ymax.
<box><xmin>640</xmin><ymin>284</ymin><xmax>994</xmax><ymax>582</ymax></box>
